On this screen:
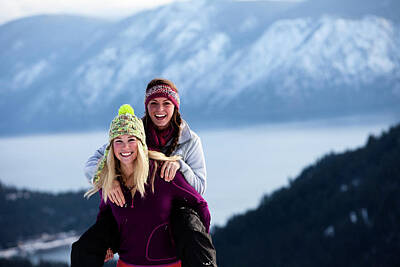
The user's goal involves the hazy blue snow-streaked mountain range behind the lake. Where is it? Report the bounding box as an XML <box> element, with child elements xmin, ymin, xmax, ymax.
<box><xmin>0</xmin><ymin>0</ymin><xmax>400</xmax><ymax>134</ymax></box>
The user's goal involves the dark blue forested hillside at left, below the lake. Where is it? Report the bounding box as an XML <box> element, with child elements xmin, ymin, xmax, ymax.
<box><xmin>0</xmin><ymin>184</ymin><xmax>99</xmax><ymax>249</ymax></box>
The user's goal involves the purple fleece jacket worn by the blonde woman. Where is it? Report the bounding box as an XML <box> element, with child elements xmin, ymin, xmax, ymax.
<box><xmin>97</xmin><ymin>163</ymin><xmax>210</xmax><ymax>265</ymax></box>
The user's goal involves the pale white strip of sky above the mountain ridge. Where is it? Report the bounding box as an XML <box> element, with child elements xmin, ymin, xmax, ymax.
<box><xmin>0</xmin><ymin>0</ymin><xmax>177</xmax><ymax>24</ymax></box>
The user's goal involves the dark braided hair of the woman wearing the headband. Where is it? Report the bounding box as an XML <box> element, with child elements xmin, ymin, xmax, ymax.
<box><xmin>142</xmin><ymin>78</ymin><xmax>182</xmax><ymax>156</ymax></box>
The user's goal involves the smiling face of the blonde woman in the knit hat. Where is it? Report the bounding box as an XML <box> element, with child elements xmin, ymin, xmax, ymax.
<box><xmin>113</xmin><ymin>134</ymin><xmax>138</xmax><ymax>165</ymax></box>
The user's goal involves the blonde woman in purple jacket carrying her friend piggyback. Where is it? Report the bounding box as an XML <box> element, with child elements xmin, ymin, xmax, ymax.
<box><xmin>71</xmin><ymin>105</ymin><xmax>210</xmax><ymax>267</ymax></box>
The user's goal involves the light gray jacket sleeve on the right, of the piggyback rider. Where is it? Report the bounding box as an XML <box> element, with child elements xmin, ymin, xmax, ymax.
<box><xmin>179</xmin><ymin>135</ymin><xmax>207</xmax><ymax>195</ymax></box>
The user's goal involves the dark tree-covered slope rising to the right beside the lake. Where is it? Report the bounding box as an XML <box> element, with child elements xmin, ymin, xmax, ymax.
<box><xmin>214</xmin><ymin>122</ymin><xmax>400</xmax><ymax>267</ymax></box>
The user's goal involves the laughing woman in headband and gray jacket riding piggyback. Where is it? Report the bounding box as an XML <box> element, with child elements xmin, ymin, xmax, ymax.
<box><xmin>79</xmin><ymin>78</ymin><xmax>217</xmax><ymax>266</ymax></box>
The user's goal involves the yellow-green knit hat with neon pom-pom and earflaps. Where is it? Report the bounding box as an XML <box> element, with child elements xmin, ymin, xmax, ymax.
<box><xmin>93</xmin><ymin>104</ymin><xmax>148</xmax><ymax>182</ymax></box>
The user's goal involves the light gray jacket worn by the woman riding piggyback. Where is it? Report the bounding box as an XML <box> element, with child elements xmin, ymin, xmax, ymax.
<box><xmin>84</xmin><ymin>120</ymin><xmax>207</xmax><ymax>195</ymax></box>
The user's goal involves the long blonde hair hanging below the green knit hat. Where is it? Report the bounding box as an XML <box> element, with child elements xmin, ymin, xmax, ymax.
<box><xmin>84</xmin><ymin>140</ymin><xmax>181</xmax><ymax>202</ymax></box>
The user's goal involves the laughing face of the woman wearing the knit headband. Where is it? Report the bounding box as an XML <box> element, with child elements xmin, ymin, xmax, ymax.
<box><xmin>147</xmin><ymin>97</ymin><xmax>175</xmax><ymax>130</ymax></box>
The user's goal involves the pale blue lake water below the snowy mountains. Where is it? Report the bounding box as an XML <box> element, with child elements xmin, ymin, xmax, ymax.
<box><xmin>0</xmin><ymin>116</ymin><xmax>398</xmax><ymax>266</ymax></box>
